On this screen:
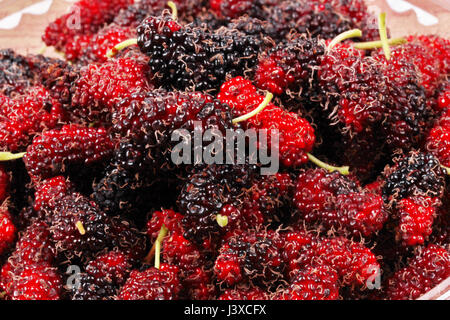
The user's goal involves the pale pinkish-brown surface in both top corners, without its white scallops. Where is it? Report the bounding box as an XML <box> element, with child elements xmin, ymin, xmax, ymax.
<box><xmin>0</xmin><ymin>0</ymin><xmax>450</xmax><ymax>55</ymax></box>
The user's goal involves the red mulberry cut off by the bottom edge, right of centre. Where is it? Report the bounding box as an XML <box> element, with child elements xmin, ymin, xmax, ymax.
<box><xmin>276</xmin><ymin>266</ymin><xmax>339</xmax><ymax>300</ymax></box>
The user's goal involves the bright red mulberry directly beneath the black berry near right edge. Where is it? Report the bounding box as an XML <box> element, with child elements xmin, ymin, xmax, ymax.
<box><xmin>397</xmin><ymin>197</ymin><xmax>439</xmax><ymax>246</ymax></box>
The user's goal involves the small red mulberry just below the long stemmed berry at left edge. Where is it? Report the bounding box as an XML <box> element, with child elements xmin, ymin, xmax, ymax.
<box><xmin>33</xmin><ymin>176</ymin><xmax>74</xmax><ymax>211</ymax></box>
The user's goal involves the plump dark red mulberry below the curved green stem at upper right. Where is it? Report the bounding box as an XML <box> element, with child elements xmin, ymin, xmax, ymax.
<box><xmin>318</xmin><ymin>45</ymin><xmax>388</xmax><ymax>132</ymax></box>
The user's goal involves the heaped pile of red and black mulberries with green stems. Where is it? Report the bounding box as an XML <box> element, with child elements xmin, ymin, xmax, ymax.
<box><xmin>0</xmin><ymin>0</ymin><xmax>450</xmax><ymax>300</ymax></box>
